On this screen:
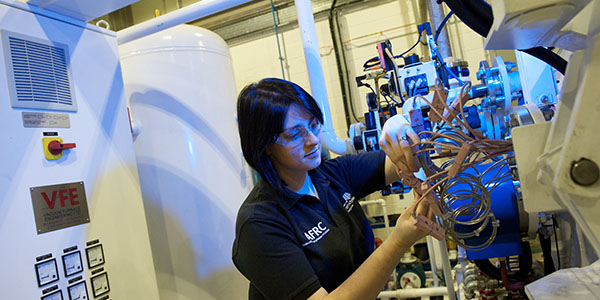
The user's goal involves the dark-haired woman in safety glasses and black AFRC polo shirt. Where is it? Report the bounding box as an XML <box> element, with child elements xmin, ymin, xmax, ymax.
<box><xmin>233</xmin><ymin>79</ymin><xmax>431</xmax><ymax>300</ymax></box>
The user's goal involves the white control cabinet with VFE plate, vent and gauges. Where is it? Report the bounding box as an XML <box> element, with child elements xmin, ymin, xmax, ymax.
<box><xmin>0</xmin><ymin>1</ymin><xmax>159</xmax><ymax>300</ymax></box>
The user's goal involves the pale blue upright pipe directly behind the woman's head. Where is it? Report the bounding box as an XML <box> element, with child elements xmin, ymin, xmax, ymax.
<box><xmin>294</xmin><ymin>0</ymin><xmax>353</xmax><ymax>154</ymax></box>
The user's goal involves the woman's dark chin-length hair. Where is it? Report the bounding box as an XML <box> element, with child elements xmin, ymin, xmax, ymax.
<box><xmin>237</xmin><ymin>78</ymin><xmax>323</xmax><ymax>190</ymax></box>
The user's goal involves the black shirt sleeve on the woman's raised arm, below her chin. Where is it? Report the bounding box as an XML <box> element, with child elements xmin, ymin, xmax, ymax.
<box><xmin>328</xmin><ymin>151</ymin><xmax>386</xmax><ymax>198</ymax></box>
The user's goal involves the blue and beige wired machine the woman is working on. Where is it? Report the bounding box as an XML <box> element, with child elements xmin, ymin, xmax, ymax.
<box><xmin>349</xmin><ymin>0</ymin><xmax>600</xmax><ymax>299</ymax></box>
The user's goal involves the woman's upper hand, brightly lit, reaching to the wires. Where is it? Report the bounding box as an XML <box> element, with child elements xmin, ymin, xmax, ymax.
<box><xmin>379</xmin><ymin>114</ymin><xmax>420</xmax><ymax>174</ymax></box>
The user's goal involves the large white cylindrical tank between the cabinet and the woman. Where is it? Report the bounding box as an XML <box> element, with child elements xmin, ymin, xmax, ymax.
<box><xmin>119</xmin><ymin>25</ymin><xmax>252</xmax><ymax>300</ymax></box>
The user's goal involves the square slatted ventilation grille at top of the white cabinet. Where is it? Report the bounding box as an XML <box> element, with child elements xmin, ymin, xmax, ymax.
<box><xmin>3</xmin><ymin>31</ymin><xmax>77</xmax><ymax>111</ymax></box>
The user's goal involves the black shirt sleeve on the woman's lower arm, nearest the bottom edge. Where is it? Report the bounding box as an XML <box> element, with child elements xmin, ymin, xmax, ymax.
<box><xmin>233</xmin><ymin>219</ymin><xmax>321</xmax><ymax>300</ymax></box>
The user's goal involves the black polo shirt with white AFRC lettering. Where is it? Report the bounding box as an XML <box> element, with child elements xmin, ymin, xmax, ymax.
<box><xmin>233</xmin><ymin>151</ymin><xmax>385</xmax><ymax>300</ymax></box>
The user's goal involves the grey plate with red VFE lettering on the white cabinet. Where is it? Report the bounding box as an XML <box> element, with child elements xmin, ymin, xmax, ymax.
<box><xmin>30</xmin><ymin>182</ymin><xmax>90</xmax><ymax>234</ymax></box>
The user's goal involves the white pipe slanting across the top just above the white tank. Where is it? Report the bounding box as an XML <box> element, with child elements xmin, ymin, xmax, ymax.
<box><xmin>117</xmin><ymin>0</ymin><xmax>250</xmax><ymax>45</ymax></box>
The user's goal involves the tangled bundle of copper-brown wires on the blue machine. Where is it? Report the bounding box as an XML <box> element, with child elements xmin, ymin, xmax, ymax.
<box><xmin>401</xmin><ymin>79</ymin><xmax>513</xmax><ymax>251</ymax></box>
